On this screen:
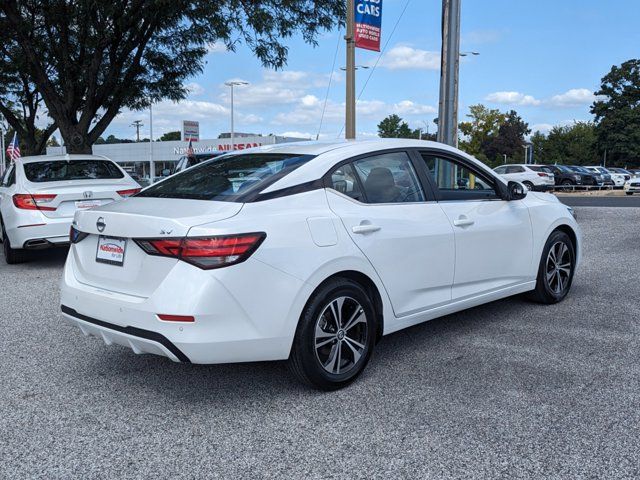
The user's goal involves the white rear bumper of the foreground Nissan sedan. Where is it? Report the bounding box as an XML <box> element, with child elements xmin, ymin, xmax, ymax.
<box><xmin>60</xmin><ymin>247</ymin><xmax>310</xmax><ymax>364</ymax></box>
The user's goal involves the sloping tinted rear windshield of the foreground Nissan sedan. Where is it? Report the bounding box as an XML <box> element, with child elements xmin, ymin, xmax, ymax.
<box><xmin>137</xmin><ymin>153</ymin><xmax>313</xmax><ymax>202</ymax></box>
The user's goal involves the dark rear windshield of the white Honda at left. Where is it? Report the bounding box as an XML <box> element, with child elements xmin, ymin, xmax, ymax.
<box><xmin>24</xmin><ymin>160</ymin><xmax>124</xmax><ymax>183</ymax></box>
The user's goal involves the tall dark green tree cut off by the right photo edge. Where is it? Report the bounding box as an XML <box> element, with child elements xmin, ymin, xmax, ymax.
<box><xmin>591</xmin><ymin>59</ymin><xmax>640</xmax><ymax>165</ymax></box>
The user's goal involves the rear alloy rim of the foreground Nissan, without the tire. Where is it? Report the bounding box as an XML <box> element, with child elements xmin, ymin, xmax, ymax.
<box><xmin>314</xmin><ymin>296</ymin><xmax>369</xmax><ymax>375</ymax></box>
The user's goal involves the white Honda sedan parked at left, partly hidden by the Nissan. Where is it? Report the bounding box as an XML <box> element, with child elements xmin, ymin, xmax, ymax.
<box><xmin>0</xmin><ymin>155</ymin><xmax>140</xmax><ymax>263</ymax></box>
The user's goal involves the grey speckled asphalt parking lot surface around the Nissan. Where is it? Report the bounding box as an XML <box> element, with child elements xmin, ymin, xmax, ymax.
<box><xmin>0</xmin><ymin>207</ymin><xmax>640</xmax><ymax>479</ymax></box>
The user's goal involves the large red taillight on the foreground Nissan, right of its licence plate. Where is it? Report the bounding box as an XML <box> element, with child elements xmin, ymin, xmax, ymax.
<box><xmin>136</xmin><ymin>232</ymin><xmax>267</xmax><ymax>270</ymax></box>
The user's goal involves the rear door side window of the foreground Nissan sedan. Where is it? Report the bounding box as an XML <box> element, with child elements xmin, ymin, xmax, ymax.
<box><xmin>353</xmin><ymin>152</ymin><xmax>425</xmax><ymax>203</ymax></box>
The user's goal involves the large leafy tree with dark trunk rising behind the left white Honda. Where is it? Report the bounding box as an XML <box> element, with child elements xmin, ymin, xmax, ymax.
<box><xmin>0</xmin><ymin>0</ymin><xmax>345</xmax><ymax>153</ymax></box>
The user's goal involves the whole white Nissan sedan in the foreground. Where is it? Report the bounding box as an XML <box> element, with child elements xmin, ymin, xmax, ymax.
<box><xmin>61</xmin><ymin>139</ymin><xmax>581</xmax><ymax>389</ymax></box>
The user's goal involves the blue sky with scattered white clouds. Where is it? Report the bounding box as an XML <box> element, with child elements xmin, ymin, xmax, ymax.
<box><xmin>106</xmin><ymin>0</ymin><xmax>640</xmax><ymax>138</ymax></box>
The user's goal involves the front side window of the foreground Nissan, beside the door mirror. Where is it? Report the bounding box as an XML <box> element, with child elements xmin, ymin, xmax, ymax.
<box><xmin>422</xmin><ymin>153</ymin><xmax>498</xmax><ymax>200</ymax></box>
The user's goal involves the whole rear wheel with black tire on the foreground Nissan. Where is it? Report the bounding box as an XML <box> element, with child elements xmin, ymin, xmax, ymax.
<box><xmin>289</xmin><ymin>278</ymin><xmax>376</xmax><ymax>390</ymax></box>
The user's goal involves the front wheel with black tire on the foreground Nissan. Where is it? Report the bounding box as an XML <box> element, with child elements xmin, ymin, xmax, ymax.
<box><xmin>529</xmin><ymin>230</ymin><xmax>576</xmax><ymax>304</ymax></box>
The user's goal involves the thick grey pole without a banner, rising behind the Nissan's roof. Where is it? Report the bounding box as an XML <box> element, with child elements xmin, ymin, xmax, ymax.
<box><xmin>438</xmin><ymin>0</ymin><xmax>461</xmax><ymax>147</ymax></box>
